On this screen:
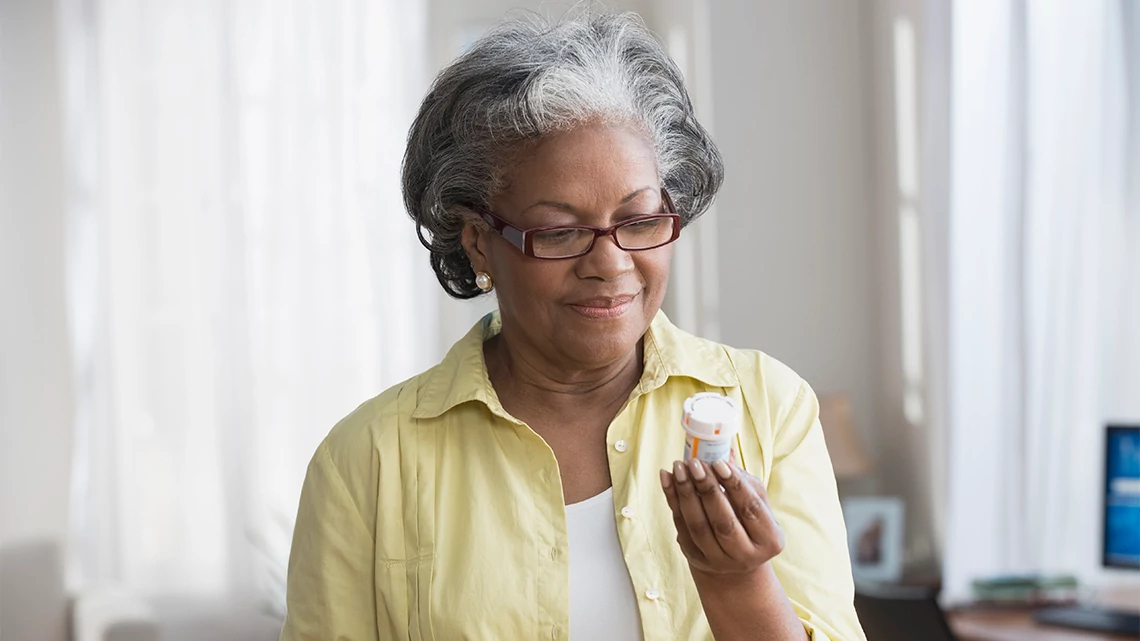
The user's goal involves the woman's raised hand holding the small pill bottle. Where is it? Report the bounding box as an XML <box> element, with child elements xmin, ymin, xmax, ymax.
<box><xmin>661</xmin><ymin>459</ymin><xmax>784</xmax><ymax>578</ymax></box>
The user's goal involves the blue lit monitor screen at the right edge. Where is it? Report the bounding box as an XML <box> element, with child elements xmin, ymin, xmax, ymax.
<box><xmin>1104</xmin><ymin>425</ymin><xmax>1140</xmax><ymax>569</ymax></box>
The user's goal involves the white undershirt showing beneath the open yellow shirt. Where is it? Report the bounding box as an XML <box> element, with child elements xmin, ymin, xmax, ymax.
<box><xmin>567</xmin><ymin>487</ymin><xmax>642</xmax><ymax>641</ymax></box>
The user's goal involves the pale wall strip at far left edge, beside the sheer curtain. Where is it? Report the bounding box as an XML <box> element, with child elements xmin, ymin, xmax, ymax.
<box><xmin>0</xmin><ymin>0</ymin><xmax>73</xmax><ymax>539</ymax></box>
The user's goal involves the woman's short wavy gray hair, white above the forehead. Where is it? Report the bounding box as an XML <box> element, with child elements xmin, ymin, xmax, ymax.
<box><xmin>404</xmin><ymin>13</ymin><xmax>724</xmax><ymax>299</ymax></box>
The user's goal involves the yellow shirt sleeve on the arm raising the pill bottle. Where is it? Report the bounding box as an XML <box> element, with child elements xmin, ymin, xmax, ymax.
<box><xmin>767</xmin><ymin>380</ymin><xmax>866</xmax><ymax>641</ymax></box>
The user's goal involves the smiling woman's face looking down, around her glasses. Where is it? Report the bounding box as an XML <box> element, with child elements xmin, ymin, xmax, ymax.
<box><xmin>463</xmin><ymin>124</ymin><xmax>673</xmax><ymax>368</ymax></box>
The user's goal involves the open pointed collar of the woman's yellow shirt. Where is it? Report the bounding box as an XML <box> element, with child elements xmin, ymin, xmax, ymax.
<box><xmin>412</xmin><ymin>310</ymin><xmax>740</xmax><ymax>419</ymax></box>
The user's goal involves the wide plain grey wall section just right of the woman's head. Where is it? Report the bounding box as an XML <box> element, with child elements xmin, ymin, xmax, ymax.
<box><xmin>710</xmin><ymin>0</ymin><xmax>878</xmax><ymax>463</ymax></box>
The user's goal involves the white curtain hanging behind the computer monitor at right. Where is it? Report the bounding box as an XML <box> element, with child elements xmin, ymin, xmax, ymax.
<box><xmin>944</xmin><ymin>0</ymin><xmax>1140</xmax><ymax>599</ymax></box>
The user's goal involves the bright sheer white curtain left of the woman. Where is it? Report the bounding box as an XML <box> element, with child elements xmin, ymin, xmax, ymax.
<box><xmin>62</xmin><ymin>0</ymin><xmax>439</xmax><ymax>602</ymax></box>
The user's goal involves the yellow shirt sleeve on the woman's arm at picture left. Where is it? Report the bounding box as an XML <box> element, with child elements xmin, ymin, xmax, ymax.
<box><xmin>280</xmin><ymin>443</ymin><xmax>378</xmax><ymax>641</ymax></box>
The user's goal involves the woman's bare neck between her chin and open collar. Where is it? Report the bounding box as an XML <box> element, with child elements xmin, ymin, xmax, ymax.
<box><xmin>483</xmin><ymin>333</ymin><xmax>643</xmax><ymax>412</ymax></box>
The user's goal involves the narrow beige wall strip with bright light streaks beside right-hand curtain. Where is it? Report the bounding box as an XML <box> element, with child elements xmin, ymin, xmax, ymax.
<box><xmin>870</xmin><ymin>0</ymin><xmax>950</xmax><ymax>574</ymax></box>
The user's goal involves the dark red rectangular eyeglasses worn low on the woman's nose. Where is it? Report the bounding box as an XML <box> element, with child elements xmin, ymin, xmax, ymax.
<box><xmin>481</xmin><ymin>188</ymin><xmax>681</xmax><ymax>260</ymax></box>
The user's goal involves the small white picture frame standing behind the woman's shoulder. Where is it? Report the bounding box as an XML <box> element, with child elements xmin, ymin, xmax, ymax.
<box><xmin>842</xmin><ymin>496</ymin><xmax>905</xmax><ymax>583</ymax></box>
